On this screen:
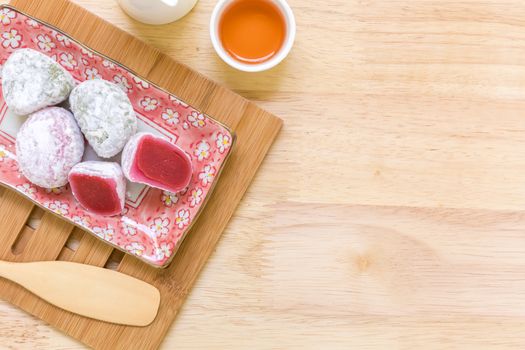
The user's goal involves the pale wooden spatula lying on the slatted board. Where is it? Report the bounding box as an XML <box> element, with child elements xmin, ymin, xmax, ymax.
<box><xmin>0</xmin><ymin>261</ymin><xmax>160</xmax><ymax>326</ymax></box>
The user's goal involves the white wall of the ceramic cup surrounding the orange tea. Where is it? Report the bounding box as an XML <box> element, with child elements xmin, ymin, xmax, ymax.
<box><xmin>210</xmin><ymin>0</ymin><xmax>296</xmax><ymax>72</ymax></box>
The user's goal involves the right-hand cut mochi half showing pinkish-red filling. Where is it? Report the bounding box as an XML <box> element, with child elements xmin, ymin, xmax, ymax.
<box><xmin>122</xmin><ymin>132</ymin><xmax>193</xmax><ymax>192</ymax></box>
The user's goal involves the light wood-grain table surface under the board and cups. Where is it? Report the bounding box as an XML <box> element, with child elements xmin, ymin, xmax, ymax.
<box><xmin>0</xmin><ymin>0</ymin><xmax>525</xmax><ymax>349</ymax></box>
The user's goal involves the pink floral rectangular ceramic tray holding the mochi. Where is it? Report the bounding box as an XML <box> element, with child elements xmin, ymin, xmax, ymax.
<box><xmin>0</xmin><ymin>6</ymin><xmax>235</xmax><ymax>267</ymax></box>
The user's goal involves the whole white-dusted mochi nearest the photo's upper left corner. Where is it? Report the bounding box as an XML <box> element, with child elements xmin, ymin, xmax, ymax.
<box><xmin>2</xmin><ymin>49</ymin><xmax>75</xmax><ymax>115</ymax></box>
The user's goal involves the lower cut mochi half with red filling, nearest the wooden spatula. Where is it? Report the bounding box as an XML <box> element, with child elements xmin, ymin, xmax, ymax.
<box><xmin>69</xmin><ymin>161</ymin><xmax>126</xmax><ymax>216</ymax></box>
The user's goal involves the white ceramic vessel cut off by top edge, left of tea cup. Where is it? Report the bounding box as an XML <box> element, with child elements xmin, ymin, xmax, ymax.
<box><xmin>118</xmin><ymin>0</ymin><xmax>199</xmax><ymax>25</ymax></box>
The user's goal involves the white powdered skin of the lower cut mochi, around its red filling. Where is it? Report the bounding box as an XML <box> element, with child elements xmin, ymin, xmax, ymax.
<box><xmin>69</xmin><ymin>161</ymin><xmax>126</xmax><ymax>213</ymax></box>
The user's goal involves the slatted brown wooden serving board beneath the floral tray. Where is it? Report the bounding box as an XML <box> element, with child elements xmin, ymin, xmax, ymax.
<box><xmin>0</xmin><ymin>0</ymin><xmax>282</xmax><ymax>349</ymax></box>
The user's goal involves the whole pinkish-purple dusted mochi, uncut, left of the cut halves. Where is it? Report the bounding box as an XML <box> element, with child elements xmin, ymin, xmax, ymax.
<box><xmin>16</xmin><ymin>107</ymin><xmax>84</xmax><ymax>188</ymax></box>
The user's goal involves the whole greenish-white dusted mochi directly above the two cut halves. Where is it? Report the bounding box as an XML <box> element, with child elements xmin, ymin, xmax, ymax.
<box><xmin>69</xmin><ymin>79</ymin><xmax>137</xmax><ymax>158</ymax></box>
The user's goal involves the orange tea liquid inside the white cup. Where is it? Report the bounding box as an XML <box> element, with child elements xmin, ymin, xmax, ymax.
<box><xmin>219</xmin><ymin>0</ymin><xmax>286</xmax><ymax>64</ymax></box>
